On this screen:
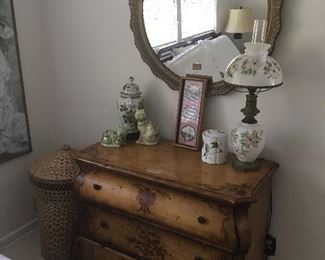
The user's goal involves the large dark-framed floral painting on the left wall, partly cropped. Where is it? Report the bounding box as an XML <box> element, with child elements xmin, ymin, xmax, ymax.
<box><xmin>0</xmin><ymin>0</ymin><xmax>32</xmax><ymax>163</ymax></box>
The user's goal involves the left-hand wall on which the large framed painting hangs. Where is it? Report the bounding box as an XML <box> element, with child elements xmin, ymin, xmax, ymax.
<box><xmin>0</xmin><ymin>0</ymin><xmax>52</xmax><ymax>244</ymax></box>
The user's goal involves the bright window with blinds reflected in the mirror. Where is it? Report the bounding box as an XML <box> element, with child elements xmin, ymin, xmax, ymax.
<box><xmin>143</xmin><ymin>0</ymin><xmax>217</xmax><ymax>48</ymax></box>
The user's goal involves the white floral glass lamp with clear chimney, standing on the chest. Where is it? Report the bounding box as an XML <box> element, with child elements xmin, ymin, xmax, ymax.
<box><xmin>224</xmin><ymin>20</ymin><xmax>283</xmax><ymax>171</ymax></box>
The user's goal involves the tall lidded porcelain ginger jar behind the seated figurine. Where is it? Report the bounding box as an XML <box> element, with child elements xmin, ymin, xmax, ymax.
<box><xmin>117</xmin><ymin>77</ymin><xmax>143</xmax><ymax>139</ymax></box>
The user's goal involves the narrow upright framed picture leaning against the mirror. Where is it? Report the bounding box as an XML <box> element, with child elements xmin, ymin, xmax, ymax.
<box><xmin>175</xmin><ymin>75</ymin><xmax>212</xmax><ymax>150</ymax></box>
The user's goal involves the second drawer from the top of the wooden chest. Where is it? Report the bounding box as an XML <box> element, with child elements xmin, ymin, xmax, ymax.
<box><xmin>81</xmin><ymin>207</ymin><xmax>231</xmax><ymax>260</ymax></box>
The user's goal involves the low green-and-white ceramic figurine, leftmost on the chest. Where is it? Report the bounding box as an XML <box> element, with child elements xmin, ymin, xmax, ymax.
<box><xmin>100</xmin><ymin>126</ymin><xmax>128</xmax><ymax>148</ymax></box>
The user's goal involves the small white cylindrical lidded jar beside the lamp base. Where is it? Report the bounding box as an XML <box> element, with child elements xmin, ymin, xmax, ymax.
<box><xmin>202</xmin><ymin>129</ymin><xmax>227</xmax><ymax>164</ymax></box>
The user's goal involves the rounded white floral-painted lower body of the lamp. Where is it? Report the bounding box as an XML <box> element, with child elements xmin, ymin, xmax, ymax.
<box><xmin>231</xmin><ymin>122</ymin><xmax>265</xmax><ymax>163</ymax></box>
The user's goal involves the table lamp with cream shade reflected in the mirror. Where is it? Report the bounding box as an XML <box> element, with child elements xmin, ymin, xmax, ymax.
<box><xmin>225</xmin><ymin>7</ymin><xmax>253</xmax><ymax>39</ymax></box>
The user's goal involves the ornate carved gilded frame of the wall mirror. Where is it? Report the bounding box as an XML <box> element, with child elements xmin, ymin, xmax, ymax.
<box><xmin>129</xmin><ymin>0</ymin><xmax>283</xmax><ymax>96</ymax></box>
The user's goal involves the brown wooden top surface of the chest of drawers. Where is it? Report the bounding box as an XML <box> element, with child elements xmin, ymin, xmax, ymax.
<box><xmin>77</xmin><ymin>140</ymin><xmax>279</xmax><ymax>205</ymax></box>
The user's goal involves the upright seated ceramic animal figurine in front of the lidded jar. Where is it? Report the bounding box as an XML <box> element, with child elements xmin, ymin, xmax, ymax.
<box><xmin>135</xmin><ymin>108</ymin><xmax>159</xmax><ymax>145</ymax></box>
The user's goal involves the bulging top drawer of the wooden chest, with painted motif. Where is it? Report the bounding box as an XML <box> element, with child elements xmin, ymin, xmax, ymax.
<box><xmin>74</xmin><ymin>168</ymin><xmax>237</xmax><ymax>252</ymax></box>
